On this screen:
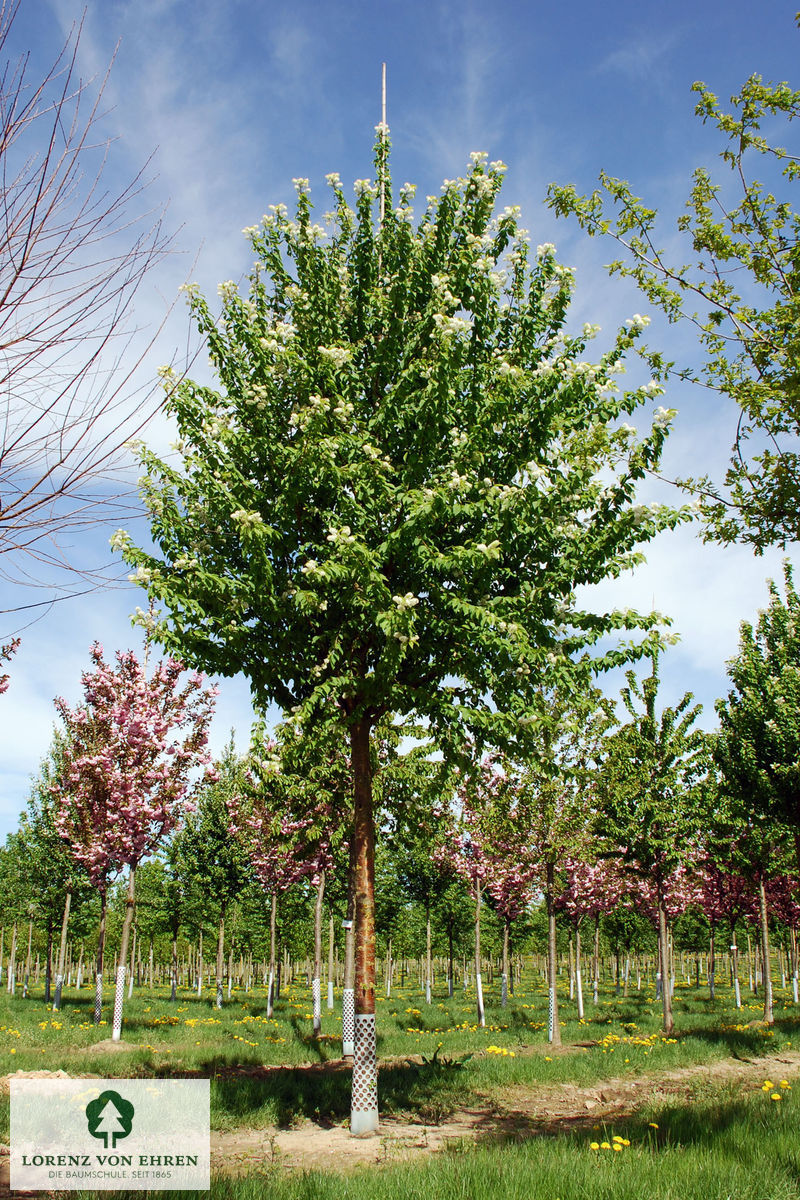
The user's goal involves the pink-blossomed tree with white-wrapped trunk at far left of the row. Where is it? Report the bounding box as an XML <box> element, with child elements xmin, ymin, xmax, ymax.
<box><xmin>53</xmin><ymin>643</ymin><xmax>217</xmax><ymax>1042</ymax></box>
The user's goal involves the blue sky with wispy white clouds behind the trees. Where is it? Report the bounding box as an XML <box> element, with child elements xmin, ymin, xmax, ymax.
<box><xmin>0</xmin><ymin>0</ymin><xmax>800</xmax><ymax>836</ymax></box>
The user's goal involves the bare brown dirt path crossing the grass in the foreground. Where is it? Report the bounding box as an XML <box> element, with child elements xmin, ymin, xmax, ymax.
<box><xmin>0</xmin><ymin>1048</ymin><xmax>800</xmax><ymax>1198</ymax></box>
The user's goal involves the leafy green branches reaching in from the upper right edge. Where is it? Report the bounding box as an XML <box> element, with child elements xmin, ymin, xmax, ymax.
<box><xmin>549</xmin><ymin>35</ymin><xmax>800</xmax><ymax>552</ymax></box>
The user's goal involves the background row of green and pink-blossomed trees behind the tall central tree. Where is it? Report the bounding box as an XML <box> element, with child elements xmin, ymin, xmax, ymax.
<box><xmin>0</xmin><ymin>566</ymin><xmax>800</xmax><ymax>1055</ymax></box>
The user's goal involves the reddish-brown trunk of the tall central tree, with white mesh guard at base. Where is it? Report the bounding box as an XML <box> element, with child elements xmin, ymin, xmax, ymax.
<box><xmin>350</xmin><ymin>718</ymin><xmax>378</xmax><ymax>1135</ymax></box>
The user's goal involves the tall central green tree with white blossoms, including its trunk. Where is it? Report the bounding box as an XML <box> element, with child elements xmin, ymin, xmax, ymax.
<box><xmin>120</xmin><ymin>136</ymin><xmax>679</xmax><ymax>1133</ymax></box>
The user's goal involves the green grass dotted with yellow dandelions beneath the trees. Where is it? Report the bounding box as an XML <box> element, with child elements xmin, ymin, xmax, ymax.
<box><xmin>0</xmin><ymin>980</ymin><xmax>800</xmax><ymax>1200</ymax></box>
